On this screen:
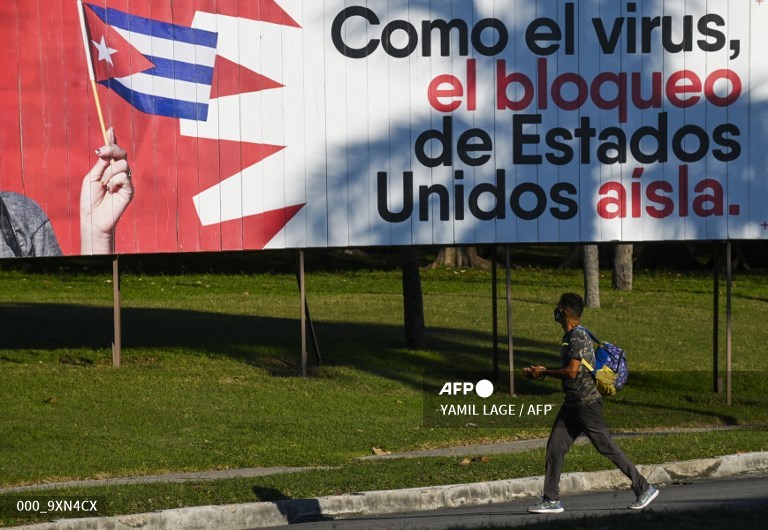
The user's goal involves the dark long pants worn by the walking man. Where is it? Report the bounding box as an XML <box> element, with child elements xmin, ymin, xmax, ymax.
<box><xmin>544</xmin><ymin>400</ymin><xmax>649</xmax><ymax>501</ymax></box>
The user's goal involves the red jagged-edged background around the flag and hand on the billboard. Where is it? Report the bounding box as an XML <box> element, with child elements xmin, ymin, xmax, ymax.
<box><xmin>0</xmin><ymin>0</ymin><xmax>302</xmax><ymax>255</ymax></box>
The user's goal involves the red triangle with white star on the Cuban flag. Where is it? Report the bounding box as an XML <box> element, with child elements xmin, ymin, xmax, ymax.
<box><xmin>85</xmin><ymin>5</ymin><xmax>155</xmax><ymax>81</ymax></box>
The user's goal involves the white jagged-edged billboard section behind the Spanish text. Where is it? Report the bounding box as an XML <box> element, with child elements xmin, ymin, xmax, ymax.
<box><xmin>186</xmin><ymin>0</ymin><xmax>768</xmax><ymax>248</ymax></box>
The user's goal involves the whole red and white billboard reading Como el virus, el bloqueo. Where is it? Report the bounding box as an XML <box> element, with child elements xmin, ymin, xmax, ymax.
<box><xmin>0</xmin><ymin>0</ymin><xmax>768</xmax><ymax>256</ymax></box>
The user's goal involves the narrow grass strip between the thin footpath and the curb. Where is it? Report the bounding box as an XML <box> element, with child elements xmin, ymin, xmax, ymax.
<box><xmin>0</xmin><ymin>429</ymin><xmax>768</xmax><ymax>528</ymax></box>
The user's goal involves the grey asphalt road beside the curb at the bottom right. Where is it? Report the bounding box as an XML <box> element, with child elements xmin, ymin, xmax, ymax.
<box><xmin>272</xmin><ymin>475</ymin><xmax>768</xmax><ymax>530</ymax></box>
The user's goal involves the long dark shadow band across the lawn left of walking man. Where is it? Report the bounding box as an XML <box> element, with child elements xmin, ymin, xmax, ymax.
<box><xmin>0</xmin><ymin>303</ymin><xmax>557</xmax><ymax>391</ymax></box>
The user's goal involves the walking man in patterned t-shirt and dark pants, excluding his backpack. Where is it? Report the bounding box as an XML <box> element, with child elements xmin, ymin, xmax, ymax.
<box><xmin>523</xmin><ymin>293</ymin><xmax>659</xmax><ymax>513</ymax></box>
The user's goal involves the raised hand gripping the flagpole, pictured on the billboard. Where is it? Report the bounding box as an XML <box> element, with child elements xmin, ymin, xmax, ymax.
<box><xmin>80</xmin><ymin>128</ymin><xmax>134</xmax><ymax>255</ymax></box>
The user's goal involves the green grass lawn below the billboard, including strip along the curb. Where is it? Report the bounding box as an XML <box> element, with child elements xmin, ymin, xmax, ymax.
<box><xmin>0</xmin><ymin>256</ymin><xmax>768</xmax><ymax>524</ymax></box>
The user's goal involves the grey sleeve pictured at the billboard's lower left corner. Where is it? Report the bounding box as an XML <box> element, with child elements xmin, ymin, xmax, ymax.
<box><xmin>0</xmin><ymin>191</ymin><xmax>61</xmax><ymax>258</ymax></box>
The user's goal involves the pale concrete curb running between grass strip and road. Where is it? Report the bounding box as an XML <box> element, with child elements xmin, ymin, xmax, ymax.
<box><xmin>13</xmin><ymin>452</ymin><xmax>768</xmax><ymax>530</ymax></box>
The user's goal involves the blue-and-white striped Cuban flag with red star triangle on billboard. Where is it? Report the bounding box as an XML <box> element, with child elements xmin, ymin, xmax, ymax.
<box><xmin>84</xmin><ymin>4</ymin><xmax>218</xmax><ymax>121</ymax></box>
